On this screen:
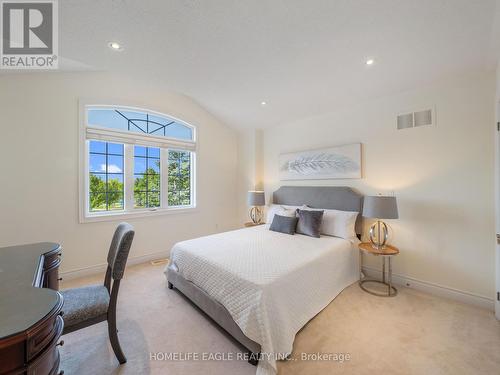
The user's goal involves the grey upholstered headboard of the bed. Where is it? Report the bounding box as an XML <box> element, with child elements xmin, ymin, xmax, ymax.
<box><xmin>273</xmin><ymin>186</ymin><xmax>363</xmax><ymax>234</ymax></box>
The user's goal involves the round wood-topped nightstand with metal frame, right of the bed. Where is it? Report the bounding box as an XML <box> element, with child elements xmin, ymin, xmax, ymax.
<box><xmin>358</xmin><ymin>242</ymin><xmax>399</xmax><ymax>297</ymax></box>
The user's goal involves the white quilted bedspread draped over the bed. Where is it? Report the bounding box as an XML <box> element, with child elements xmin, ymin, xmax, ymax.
<box><xmin>166</xmin><ymin>225</ymin><xmax>359</xmax><ymax>374</ymax></box>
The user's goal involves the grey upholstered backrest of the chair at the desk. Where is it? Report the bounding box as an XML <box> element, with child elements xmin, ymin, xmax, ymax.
<box><xmin>108</xmin><ymin>223</ymin><xmax>135</xmax><ymax>280</ymax></box>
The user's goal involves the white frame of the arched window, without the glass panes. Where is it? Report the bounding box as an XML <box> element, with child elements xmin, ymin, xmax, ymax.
<box><xmin>79</xmin><ymin>100</ymin><xmax>199</xmax><ymax>223</ymax></box>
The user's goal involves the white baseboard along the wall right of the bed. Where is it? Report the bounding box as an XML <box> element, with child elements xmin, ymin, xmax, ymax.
<box><xmin>363</xmin><ymin>266</ymin><xmax>495</xmax><ymax>311</ymax></box>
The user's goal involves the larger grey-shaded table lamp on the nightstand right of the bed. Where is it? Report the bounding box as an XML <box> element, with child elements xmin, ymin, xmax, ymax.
<box><xmin>363</xmin><ymin>195</ymin><xmax>399</xmax><ymax>249</ymax></box>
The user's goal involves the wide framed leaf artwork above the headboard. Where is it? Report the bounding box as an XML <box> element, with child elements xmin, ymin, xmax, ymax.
<box><xmin>279</xmin><ymin>143</ymin><xmax>361</xmax><ymax>180</ymax></box>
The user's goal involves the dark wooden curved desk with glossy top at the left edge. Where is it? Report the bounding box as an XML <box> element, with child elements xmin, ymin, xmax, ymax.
<box><xmin>0</xmin><ymin>242</ymin><xmax>64</xmax><ymax>375</ymax></box>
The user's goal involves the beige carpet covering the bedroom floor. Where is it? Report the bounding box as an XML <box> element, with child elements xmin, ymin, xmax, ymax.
<box><xmin>61</xmin><ymin>264</ymin><xmax>500</xmax><ymax>375</ymax></box>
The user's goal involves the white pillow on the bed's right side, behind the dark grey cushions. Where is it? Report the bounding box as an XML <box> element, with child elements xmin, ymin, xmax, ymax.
<box><xmin>301</xmin><ymin>205</ymin><xmax>359</xmax><ymax>240</ymax></box>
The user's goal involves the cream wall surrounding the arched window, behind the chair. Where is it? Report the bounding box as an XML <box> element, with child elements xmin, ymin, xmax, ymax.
<box><xmin>0</xmin><ymin>73</ymin><xmax>237</xmax><ymax>271</ymax></box>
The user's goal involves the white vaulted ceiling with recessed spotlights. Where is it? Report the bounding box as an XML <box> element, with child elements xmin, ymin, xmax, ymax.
<box><xmin>47</xmin><ymin>0</ymin><xmax>499</xmax><ymax>127</ymax></box>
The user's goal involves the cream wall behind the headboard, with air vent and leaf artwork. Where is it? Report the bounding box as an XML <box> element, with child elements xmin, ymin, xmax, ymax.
<box><xmin>264</xmin><ymin>74</ymin><xmax>495</xmax><ymax>301</ymax></box>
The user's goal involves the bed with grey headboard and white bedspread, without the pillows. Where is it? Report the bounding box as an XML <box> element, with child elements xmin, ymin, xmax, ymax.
<box><xmin>165</xmin><ymin>187</ymin><xmax>363</xmax><ymax>374</ymax></box>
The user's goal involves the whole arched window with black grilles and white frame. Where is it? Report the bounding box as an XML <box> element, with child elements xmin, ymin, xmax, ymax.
<box><xmin>80</xmin><ymin>105</ymin><xmax>196</xmax><ymax>221</ymax></box>
